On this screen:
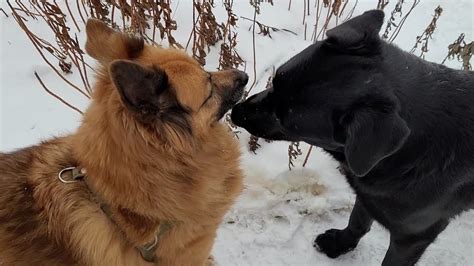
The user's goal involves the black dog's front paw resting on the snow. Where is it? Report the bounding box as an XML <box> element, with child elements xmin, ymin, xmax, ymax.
<box><xmin>313</xmin><ymin>229</ymin><xmax>358</xmax><ymax>259</ymax></box>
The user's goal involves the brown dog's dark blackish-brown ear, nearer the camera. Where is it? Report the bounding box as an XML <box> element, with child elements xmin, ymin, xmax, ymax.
<box><xmin>109</xmin><ymin>60</ymin><xmax>168</xmax><ymax>114</ymax></box>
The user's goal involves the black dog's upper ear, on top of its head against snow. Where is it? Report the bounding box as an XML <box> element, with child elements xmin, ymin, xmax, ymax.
<box><xmin>325</xmin><ymin>10</ymin><xmax>384</xmax><ymax>50</ymax></box>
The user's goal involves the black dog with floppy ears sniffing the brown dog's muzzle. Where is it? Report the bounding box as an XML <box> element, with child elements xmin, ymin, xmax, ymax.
<box><xmin>232</xmin><ymin>11</ymin><xmax>474</xmax><ymax>266</ymax></box>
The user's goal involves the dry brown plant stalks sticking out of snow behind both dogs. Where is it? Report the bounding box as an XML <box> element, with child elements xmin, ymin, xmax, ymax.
<box><xmin>10</xmin><ymin>0</ymin><xmax>466</xmax><ymax>169</ymax></box>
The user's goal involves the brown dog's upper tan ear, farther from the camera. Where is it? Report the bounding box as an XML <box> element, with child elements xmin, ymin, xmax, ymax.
<box><xmin>85</xmin><ymin>19</ymin><xmax>145</xmax><ymax>65</ymax></box>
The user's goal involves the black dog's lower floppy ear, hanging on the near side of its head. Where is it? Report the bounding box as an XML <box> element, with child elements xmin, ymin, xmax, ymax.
<box><xmin>342</xmin><ymin>95</ymin><xmax>410</xmax><ymax>176</ymax></box>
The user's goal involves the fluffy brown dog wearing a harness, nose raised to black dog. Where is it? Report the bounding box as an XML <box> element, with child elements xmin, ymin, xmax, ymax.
<box><xmin>0</xmin><ymin>20</ymin><xmax>248</xmax><ymax>265</ymax></box>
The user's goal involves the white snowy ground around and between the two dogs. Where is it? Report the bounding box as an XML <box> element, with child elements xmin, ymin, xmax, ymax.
<box><xmin>0</xmin><ymin>0</ymin><xmax>474</xmax><ymax>265</ymax></box>
